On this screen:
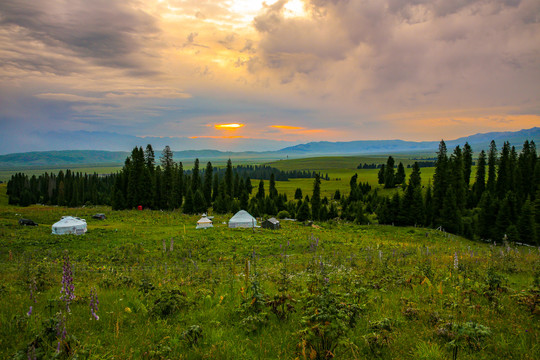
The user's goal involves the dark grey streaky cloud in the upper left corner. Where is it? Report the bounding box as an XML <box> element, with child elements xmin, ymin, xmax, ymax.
<box><xmin>0</xmin><ymin>0</ymin><xmax>159</xmax><ymax>73</ymax></box>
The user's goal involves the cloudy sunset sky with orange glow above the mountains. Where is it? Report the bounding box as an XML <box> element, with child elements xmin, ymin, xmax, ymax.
<box><xmin>0</xmin><ymin>0</ymin><xmax>540</xmax><ymax>150</ymax></box>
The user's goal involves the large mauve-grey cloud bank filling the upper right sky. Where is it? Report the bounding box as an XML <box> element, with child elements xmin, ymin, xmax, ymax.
<box><xmin>249</xmin><ymin>0</ymin><xmax>540</xmax><ymax>112</ymax></box>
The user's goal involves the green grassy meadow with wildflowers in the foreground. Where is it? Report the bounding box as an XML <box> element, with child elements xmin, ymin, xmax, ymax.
<box><xmin>0</xmin><ymin>185</ymin><xmax>540</xmax><ymax>359</ymax></box>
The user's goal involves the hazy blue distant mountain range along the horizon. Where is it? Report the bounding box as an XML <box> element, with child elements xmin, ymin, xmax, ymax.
<box><xmin>0</xmin><ymin>127</ymin><xmax>540</xmax><ymax>169</ymax></box>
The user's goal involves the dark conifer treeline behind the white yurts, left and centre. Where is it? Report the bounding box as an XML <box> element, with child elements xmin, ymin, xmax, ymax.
<box><xmin>7</xmin><ymin>145</ymin><xmax>328</xmax><ymax>213</ymax></box>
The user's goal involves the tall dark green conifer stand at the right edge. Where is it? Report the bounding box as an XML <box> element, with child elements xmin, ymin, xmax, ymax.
<box><xmin>371</xmin><ymin>141</ymin><xmax>540</xmax><ymax>244</ymax></box>
